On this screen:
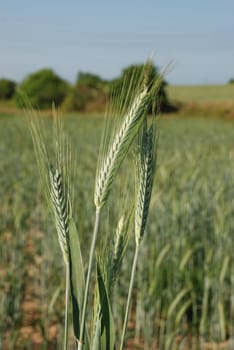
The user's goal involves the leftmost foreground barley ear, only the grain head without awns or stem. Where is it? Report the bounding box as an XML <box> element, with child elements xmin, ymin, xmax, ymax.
<box><xmin>49</xmin><ymin>166</ymin><xmax>69</xmax><ymax>264</ymax></box>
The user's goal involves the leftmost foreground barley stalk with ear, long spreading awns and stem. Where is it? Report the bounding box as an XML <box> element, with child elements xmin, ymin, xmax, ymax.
<box><xmin>28</xmin><ymin>109</ymin><xmax>71</xmax><ymax>350</ymax></box>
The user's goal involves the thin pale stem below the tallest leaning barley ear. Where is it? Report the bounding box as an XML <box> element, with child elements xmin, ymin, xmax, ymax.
<box><xmin>78</xmin><ymin>208</ymin><xmax>100</xmax><ymax>350</ymax></box>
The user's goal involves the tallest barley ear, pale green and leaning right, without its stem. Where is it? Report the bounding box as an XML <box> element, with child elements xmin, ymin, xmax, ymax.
<box><xmin>94</xmin><ymin>88</ymin><xmax>149</xmax><ymax>209</ymax></box>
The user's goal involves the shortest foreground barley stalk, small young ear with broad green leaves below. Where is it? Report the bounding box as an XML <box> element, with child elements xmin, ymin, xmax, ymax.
<box><xmin>91</xmin><ymin>177</ymin><xmax>133</xmax><ymax>350</ymax></box>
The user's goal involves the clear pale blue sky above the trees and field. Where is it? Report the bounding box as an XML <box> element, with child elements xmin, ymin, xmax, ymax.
<box><xmin>0</xmin><ymin>0</ymin><xmax>234</xmax><ymax>84</ymax></box>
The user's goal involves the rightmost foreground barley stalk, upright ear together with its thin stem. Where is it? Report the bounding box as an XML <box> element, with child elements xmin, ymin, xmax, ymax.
<box><xmin>120</xmin><ymin>121</ymin><xmax>156</xmax><ymax>350</ymax></box>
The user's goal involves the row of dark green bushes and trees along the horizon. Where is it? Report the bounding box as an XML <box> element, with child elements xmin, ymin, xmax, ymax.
<box><xmin>0</xmin><ymin>62</ymin><xmax>176</xmax><ymax>112</ymax></box>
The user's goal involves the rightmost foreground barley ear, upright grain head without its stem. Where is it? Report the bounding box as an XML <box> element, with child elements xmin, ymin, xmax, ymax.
<box><xmin>135</xmin><ymin>121</ymin><xmax>156</xmax><ymax>245</ymax></box>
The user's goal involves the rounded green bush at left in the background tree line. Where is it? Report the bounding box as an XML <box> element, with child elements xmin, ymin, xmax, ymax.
<box><xmin>16</xmin><ymin>69</ymin><xmax>68</xmax><ymax>109</ymax></box>
